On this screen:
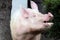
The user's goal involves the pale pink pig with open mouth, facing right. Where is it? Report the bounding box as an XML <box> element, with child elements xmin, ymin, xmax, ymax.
<box><xmin>10</xmin><ymin>1</ymin><xmax>53</xmax><ymax>40</ymax></box>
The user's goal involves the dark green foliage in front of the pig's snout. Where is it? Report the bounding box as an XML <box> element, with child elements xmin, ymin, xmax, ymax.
<box><xmin>43</xmin><ymin>0</ymin><xmax>60</xmax><ymax>38</ymax></box>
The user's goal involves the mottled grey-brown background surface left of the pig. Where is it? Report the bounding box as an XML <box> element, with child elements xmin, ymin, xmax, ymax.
<box><xmin>0</xmin><ymin>0</ymin><xmax>12</xmax><ymax>40</ymax></box>
